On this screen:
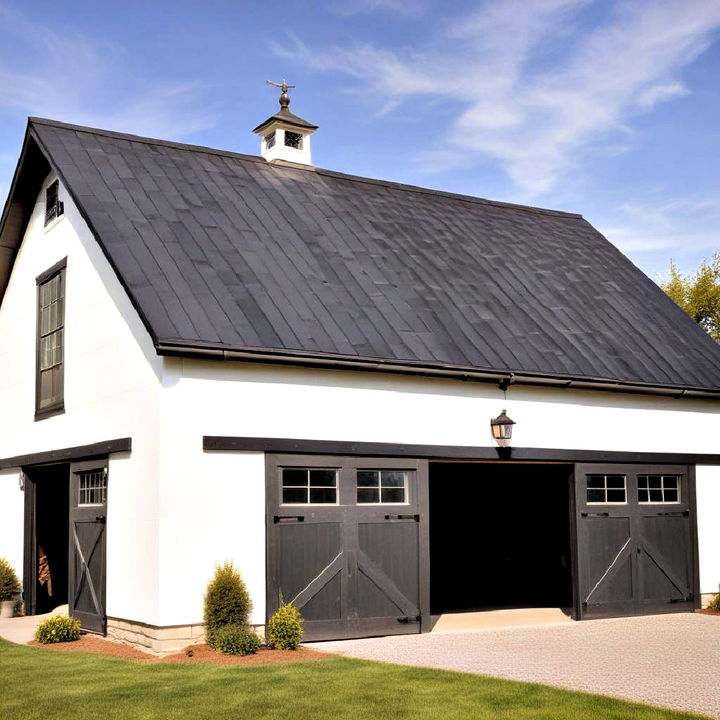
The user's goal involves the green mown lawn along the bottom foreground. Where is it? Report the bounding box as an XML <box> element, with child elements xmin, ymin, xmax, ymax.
<box><xmin>0</xmin><ymin>640</ymin><xmax>700</xmax><ymax>720</ymax></box>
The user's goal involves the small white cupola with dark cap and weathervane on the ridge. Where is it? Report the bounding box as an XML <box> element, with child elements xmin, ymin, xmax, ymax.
<box><xmin>253</xmin><ymin>80</ymin><xmax>318</xmax><ymax>165</ymax></box>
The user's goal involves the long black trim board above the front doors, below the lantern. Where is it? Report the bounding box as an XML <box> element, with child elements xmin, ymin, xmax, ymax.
<box><xmin>201</xmin><ymin>435</ymin><xmax>720</xmax><ymax>467</ymax></box>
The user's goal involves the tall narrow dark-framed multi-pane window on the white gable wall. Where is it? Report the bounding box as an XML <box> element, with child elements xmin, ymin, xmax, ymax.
<box><xmin>35</xmin><ymin>260</ymin><xmax>66</xmax><ymax>419</ymax></box>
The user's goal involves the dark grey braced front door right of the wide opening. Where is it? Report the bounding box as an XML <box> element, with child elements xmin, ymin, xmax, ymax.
<box><xmin>575</xmin><ymin>464</ymin><xmax>698</xmax><ymax>618</ymax></box>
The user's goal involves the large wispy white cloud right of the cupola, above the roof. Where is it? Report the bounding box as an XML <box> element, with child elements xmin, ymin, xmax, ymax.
<box><xmin>276</xmin><ymin>0</ymin><xmax>720</xmax><ymax>196</ymax></box>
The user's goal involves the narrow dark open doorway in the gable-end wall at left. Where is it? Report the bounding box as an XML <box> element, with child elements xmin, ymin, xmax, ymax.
<box><xmin>25</xmin><ymin>463</ymin><xmax>70</xmax><ymax>615</ymax></box>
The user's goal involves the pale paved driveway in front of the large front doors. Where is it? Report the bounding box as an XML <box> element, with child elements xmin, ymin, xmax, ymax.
<box><xmin>311</xmin><ymin>613</ymin><xmax>720</xmax><ymax>719</ymax></box>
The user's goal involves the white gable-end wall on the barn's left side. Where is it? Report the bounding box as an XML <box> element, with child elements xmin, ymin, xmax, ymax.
<box><xmin>0</xmin><ymin>177</ymin><xmax>162</xmax><ymax>623</ymax></box>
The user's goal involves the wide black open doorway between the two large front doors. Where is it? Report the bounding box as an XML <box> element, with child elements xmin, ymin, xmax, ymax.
<box><xmin>430</xmin><ymin>463</ymin><xmax>573</xmax><ymax>614</ymax></box>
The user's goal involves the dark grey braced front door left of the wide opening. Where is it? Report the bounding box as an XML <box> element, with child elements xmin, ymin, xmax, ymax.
<box><xmin>266</xmin><ymin>455</ymin><xmax>429</xmax><ymax>640</ymax></box>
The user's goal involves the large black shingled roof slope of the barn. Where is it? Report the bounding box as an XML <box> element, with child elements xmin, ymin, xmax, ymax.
<box><xmin>0</xmin><ymin>119</ymin><xmax>720</xmax><ymax>391</ymax></box>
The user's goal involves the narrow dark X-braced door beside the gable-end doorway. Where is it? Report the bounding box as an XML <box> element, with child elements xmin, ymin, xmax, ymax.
<box><xmin>68</xmin><ymin>460</ymin><xmax>108</xmax><ymax>634</ymax></box>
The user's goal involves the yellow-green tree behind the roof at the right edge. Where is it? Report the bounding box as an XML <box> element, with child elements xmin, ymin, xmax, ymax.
<box><xmin>660</xmin><ymin>252</ymin><xmax>720</xmax><ymax>342</ymax></box>
